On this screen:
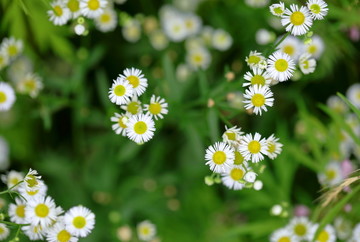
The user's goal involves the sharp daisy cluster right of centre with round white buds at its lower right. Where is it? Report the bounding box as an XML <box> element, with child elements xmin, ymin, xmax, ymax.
<box><xmin>205</xmin><ymin>126</ymin><xmax>282</xmax><ymax>190</ymax></box>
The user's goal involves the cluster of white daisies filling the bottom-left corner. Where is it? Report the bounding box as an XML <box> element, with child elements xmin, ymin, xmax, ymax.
<box><xmin>0</xmin><ymin>169</ymin><xmax>95</xmax><ymax>242</ymax></box>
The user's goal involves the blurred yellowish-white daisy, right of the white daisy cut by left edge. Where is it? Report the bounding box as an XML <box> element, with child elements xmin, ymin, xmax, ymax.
<box><xmin>17</xmin><ymin>73</ymin><xmax>43</xmax><ymax>98</ymax></box>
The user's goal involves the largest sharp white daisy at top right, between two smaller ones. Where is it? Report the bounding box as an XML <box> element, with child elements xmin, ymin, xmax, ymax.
<box><xmin>281</xmin><ymin>4</ymin><xmax>313</xmax><ymax>35</ymax></box>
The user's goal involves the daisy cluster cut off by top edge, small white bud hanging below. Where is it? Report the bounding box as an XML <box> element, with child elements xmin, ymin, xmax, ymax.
<box><xmin>48</xmin><ymin>0</ymin><xmax>119</xmax><ymax>35</ymax></box>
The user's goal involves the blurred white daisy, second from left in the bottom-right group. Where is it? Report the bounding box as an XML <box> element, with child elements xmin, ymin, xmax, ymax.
<box><xmin>288</xmin><ymin>217</ymin><xmax>313</xmax><ymax>241</ymax></box>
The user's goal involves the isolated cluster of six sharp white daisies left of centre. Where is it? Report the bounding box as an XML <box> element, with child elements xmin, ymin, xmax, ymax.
<box><xmin>109</xmin><ymin>68</ymin><xmax>168</xmax><ymax>144</ymax></box>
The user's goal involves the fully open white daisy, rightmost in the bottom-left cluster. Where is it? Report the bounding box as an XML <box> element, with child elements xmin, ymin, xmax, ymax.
<box><xmin>64</xmin><ymin>206</ymin><xmax>95</xmax><ymax>237</ymax></box>
